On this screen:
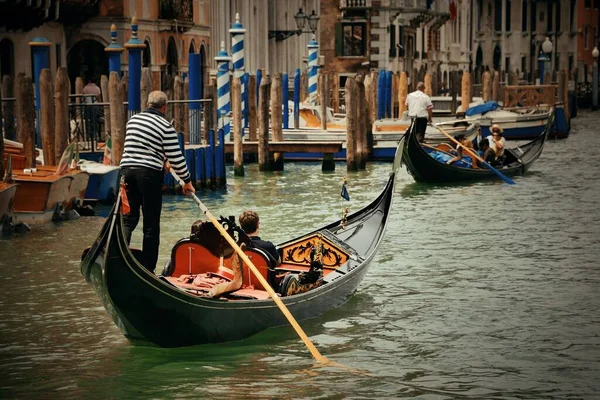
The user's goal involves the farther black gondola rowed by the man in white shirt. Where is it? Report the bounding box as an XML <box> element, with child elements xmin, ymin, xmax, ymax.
<box><xmin>402</xmin><ymin>114</ymin><xmax>554</xmax><ymax>183</ymax></box>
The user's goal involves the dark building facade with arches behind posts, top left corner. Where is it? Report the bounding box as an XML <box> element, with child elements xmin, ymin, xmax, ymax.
<box><xmin>0</xmin><ymin>0</ymin><xmax>211</xmax><ymax>92</ymax></box>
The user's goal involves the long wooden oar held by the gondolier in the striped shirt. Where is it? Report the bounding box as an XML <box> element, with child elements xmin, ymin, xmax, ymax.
<box><xmin>170</xmin><ymin>169</ymin><xmax>332</xmax><ymax>367</ymax></box>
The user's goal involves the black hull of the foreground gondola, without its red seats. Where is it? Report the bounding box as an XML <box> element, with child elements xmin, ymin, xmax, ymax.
<box><xmin>81</xmin><ymin>141</ymin><xmax>398</xmax><ymax>347</ymax></box>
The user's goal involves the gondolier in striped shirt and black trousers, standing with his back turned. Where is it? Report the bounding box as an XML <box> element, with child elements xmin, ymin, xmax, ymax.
<box><xmin>121</xmin><ymin>90</ymin><xmax>195</xmax><ymax>272</ymax></box>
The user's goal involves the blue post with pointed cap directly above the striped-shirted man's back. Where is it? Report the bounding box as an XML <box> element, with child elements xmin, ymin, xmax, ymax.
<box><xmin>125</xmin><ymin>17</ymin><xmax>146</xmax><ymax>117</ymax></box>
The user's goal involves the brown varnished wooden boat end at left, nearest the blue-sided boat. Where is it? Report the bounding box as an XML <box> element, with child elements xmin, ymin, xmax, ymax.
<box><xmin>13</xmin><ymin>170</ymin><xmax>73</xmax><ymax>225</ymax></box>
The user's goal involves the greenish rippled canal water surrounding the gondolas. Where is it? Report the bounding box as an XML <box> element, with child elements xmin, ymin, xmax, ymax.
<box><xmin>0</xmin><ymin>111</ymin><xmax>600</xmax><ymax>399</ymax></box>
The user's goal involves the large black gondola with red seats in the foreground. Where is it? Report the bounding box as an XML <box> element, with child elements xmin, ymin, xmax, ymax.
<box><xmin>81</xmin><ymin>141</ymin><xmax>402</xmax><ymax>347</ymax></box>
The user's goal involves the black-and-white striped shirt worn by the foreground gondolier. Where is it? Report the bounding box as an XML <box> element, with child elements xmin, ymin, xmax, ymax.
<box><xmin>121</xmin><ymin>108</ymin><xmax>190</xmax><ymax>183</ymax></box>
